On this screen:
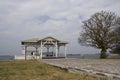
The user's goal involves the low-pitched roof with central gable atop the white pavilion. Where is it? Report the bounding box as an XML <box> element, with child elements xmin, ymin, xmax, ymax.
<box><xmin>21</xmin><ymin>36</ymin><xmax>68</xmax><ymax>44</ymax></box>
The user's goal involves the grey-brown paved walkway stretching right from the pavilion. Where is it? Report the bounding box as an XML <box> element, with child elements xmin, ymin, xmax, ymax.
<box><xmin>42</xmin><ymin>59</ymin><xmax>120</xmax><ymax>80</ymax></box>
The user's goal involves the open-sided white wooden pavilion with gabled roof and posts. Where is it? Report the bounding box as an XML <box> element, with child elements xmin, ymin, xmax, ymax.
<box><xmin>21</xmin><ymin>36</ymin><xmax>68</xmax><ymax>60</ymax></box>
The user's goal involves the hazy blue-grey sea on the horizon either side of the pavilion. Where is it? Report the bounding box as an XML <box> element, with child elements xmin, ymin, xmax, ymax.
<box><xmin>0</xmin><ymin>54</ymin><xmax>99</xmax><ymax>60</ymax></box>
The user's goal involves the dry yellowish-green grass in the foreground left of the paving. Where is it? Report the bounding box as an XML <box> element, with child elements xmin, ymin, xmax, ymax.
<box><xmin>0</xmin><ymin>61</ymin><xmax>105</xmax><ymax>80</ymax></box>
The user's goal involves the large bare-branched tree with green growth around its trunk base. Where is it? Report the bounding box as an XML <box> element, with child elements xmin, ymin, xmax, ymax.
<box><xmin>78</xmin><ymin>11</ymin><xmax>117</xmax><ymax>58</ymax></box>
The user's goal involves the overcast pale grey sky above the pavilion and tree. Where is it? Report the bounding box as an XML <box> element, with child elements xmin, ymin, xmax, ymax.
<box><xmin>0</xmin><ymin>0</ymin><xmax>120</xmax><ymax>55</ymax></box>
